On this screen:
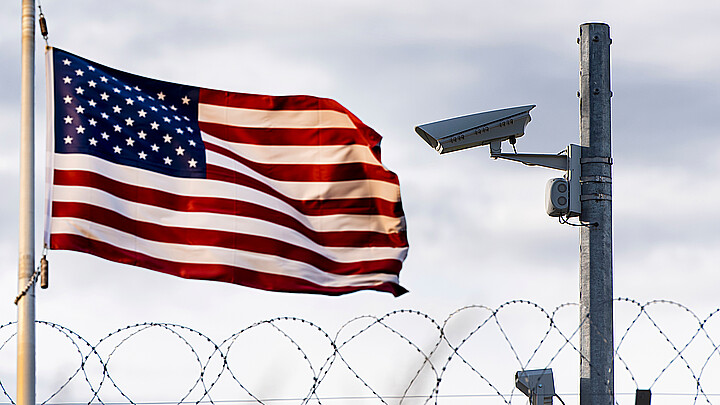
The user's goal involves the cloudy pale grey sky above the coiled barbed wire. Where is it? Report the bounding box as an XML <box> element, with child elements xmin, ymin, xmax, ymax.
<box><xmin>0</xmin><ymin>0</ymin><xmax>720</xmax><ymax>402</ymax></box>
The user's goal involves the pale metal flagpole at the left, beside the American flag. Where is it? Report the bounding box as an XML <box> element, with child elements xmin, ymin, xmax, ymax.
<box><xmin>16</xmin><ymin>0</ymin><xmax>35</xmax><ymax>405</ymax></box>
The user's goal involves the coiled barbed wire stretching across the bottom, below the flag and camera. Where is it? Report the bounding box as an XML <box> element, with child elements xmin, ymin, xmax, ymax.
<box><xmin>0</xmin><ymin>298</ymin><xmax>720</xmax><ymax>405</ymax></box>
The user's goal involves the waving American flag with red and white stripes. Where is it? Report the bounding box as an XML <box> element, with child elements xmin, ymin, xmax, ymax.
<box><xmin>45</xmin><ymin>48</ymin><xmax>408</xmax><ymax>296</ymax></box>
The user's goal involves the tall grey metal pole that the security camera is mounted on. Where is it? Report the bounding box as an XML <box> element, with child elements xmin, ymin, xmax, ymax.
<box><xmin>578</xmin><ymin>23</ymin><xmax>615</xmax><ymax>405</ymax></box>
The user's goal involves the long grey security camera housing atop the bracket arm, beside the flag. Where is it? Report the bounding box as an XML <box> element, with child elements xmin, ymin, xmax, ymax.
<box><xmin>415</xmin><ymin>105</ymin><xmax>535</xmax><ymax>154</ymax></box>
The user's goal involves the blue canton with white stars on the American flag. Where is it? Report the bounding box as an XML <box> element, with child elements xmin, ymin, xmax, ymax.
<box><xmin>54</xmin><ymin>50</ymin><xmax>205</xmax><ymax>177</ymax></box>
